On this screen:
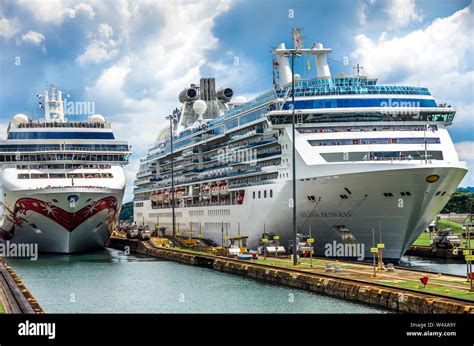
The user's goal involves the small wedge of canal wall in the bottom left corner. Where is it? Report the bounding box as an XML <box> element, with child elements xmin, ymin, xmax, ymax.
<box><xmin>0</xmin><ymin>258</ymin><xmax>44</xmax><ymax>314</ymax></box>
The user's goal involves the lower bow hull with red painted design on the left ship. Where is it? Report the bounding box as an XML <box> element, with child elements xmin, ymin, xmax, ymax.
<box><xmin>1</xmin><ymin>187</ymin><xmax>123</xmax><ymax>253</ymax></box>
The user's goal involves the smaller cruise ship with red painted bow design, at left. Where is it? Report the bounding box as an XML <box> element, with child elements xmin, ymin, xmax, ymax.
<box><xmin>0</xmin><ymin>86</ymin><xmax>131</xmax><ymax>253</ymax></box>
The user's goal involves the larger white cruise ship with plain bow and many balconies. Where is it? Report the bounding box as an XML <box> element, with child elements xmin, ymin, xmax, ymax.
<box><xmin>134</xmin><ymin>33</ymin><xmax>467</xmax><ymax>261</ymax></box>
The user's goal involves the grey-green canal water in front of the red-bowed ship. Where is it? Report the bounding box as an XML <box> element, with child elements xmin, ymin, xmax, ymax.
<box><xmin>8</xmin><ymin>249</ymin><xmax>387</xmax><ymax>313</ymax></box>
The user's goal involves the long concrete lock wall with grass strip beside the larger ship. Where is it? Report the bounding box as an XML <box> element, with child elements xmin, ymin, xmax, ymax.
<box><xmin>108</xmin><ymin>236</ymin><xmax>474</xmax><ymax>314</ymax></box>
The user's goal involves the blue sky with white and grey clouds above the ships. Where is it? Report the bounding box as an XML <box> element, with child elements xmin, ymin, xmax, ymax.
<box><xmin>0</xmin><ymin>0</ymin><xmax>474</xmax><ymax>201</ymax></box>
